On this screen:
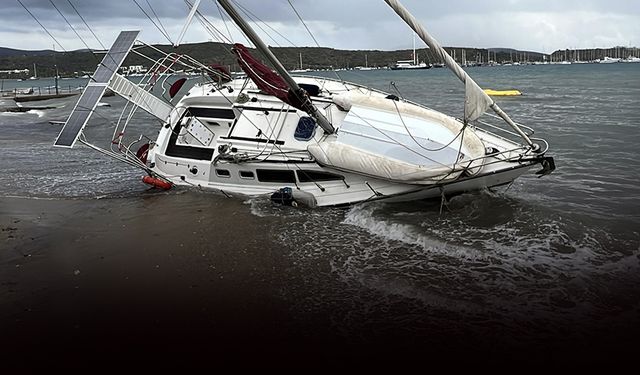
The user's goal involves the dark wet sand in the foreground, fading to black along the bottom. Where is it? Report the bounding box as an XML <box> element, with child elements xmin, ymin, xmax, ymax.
<box><xmin>0</xmin><ymin>193</ymin><xmax>635</xmax><ymax>370</ymax></box>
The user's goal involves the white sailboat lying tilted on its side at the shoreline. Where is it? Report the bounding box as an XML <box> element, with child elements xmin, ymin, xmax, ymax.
<box><xmin>56</xmin><ymin>0</ymin><xmax>555</xmax><ymax>206</ymax></box>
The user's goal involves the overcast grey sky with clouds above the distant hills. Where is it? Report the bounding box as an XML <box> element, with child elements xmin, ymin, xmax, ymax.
<box><xmin>5</xmin><ymin>0</ymin><xmax>640</xmax><ymax>53</ymax></box>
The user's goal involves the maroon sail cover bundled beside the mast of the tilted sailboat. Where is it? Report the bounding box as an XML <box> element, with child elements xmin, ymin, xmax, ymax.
<box><xmin>233</xmin><ymin>43</ymin><xmax>305</xmax><ymax>111</ymax></box>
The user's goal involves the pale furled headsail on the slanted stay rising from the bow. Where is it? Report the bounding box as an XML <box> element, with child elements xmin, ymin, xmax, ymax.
<box><xmin>384</xmin><ymin>0</ymin><xmax>540</xmax><ymax>151</ymax></box>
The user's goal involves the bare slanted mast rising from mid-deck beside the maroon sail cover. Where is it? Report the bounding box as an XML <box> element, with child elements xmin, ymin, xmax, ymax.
<box><xmin>218</xmin><ymin>0</ymin><xmax>335</xmax><ymax>134</ymax></box>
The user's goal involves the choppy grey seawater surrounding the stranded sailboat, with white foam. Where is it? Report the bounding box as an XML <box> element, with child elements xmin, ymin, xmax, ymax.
<box><xmin>0</xmin><ymin>64</ymin><xmax>640</xmax><ymax>356</ymax></box>
